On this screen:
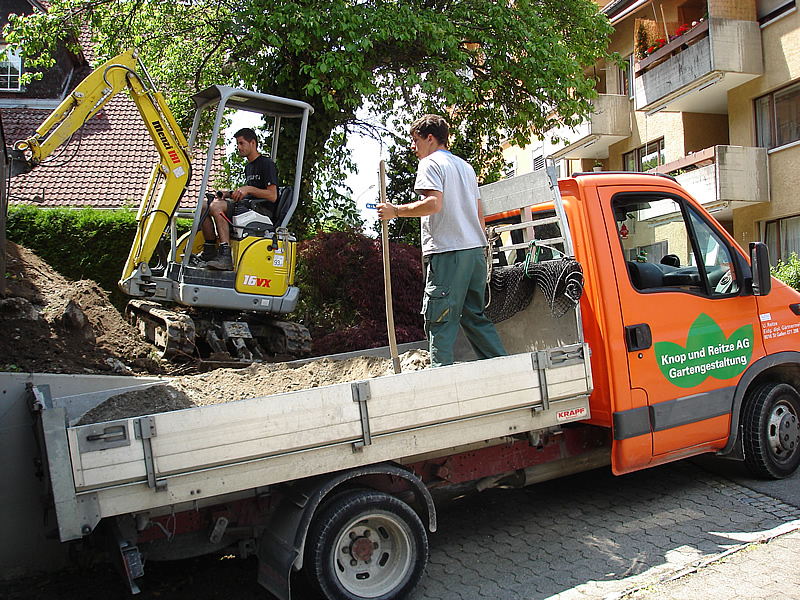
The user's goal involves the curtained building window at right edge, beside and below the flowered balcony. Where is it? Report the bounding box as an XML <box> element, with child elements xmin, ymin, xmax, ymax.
<box><xmin>755</xmin><ymin>83</ymin><xmax>800</xmax><ymax>148</ymax></box>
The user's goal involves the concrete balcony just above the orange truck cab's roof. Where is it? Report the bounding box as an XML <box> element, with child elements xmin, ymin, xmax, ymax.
<box><xmin>652</xmin><ymin>146</ymin><xmax>769</xmax><ymax>220</ymax></box>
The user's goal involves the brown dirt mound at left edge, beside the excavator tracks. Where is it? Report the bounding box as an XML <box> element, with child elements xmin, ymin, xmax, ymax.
<box><xmin>0</xmin><ymin>241</ymin><xmax>164</xmax><ymax>374</ymax></box>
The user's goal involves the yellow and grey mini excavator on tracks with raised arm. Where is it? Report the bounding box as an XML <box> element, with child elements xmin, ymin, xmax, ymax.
<box><xmin>14</xmin><ymin>50</ymin><xmax>313</xmax><ymax>364</ymax></box>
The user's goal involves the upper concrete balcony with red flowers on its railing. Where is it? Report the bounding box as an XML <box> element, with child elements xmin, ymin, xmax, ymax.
<box><xmin>633</xmin><ymin>17</ymin><xmax>764</xmax><ymax>114</ymax></box>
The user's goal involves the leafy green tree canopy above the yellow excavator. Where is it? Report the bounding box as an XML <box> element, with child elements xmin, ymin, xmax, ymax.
<box><xmin>4</xmin><ymin>0</ymin><xmax>614</xmax><ymax>239</ymax></box>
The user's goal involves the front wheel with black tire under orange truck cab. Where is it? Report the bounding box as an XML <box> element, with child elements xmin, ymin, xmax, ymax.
<box><xmin>742</xmin><ymin>383</ymin><xmax>800</xmax><ymax>479</ymax></box>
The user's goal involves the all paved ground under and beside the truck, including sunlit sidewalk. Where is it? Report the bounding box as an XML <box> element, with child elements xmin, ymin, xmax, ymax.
<box><xmin>0</xmin><ymin>461</ymin><xmax>800</xmax><ymax>600</ymax></box>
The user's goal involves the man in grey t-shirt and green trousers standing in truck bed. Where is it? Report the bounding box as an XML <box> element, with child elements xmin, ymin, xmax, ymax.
<box><xmin>378</xmin><ymin>115</ymin><xmax>506</xmax><ymax>367</ymax></box>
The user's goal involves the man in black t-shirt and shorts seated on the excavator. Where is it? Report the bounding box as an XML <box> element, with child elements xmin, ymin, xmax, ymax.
<box><xmin>199</xmin><ymin>127</ymin><xmax>278</xmax><ymax>271</ymax></box>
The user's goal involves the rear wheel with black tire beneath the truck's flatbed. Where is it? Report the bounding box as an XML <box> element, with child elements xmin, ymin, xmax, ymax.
<box><xmin>304</xmin><ymin>489</ymin><xmax>428</xmax><ymax>600</ymax></box>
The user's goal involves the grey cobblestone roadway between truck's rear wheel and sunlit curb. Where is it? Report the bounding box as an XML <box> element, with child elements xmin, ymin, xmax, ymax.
<box><xmin>412</xmin><ymin>462</ymin><xmax>800</xmax><ymax>600</ymax></box>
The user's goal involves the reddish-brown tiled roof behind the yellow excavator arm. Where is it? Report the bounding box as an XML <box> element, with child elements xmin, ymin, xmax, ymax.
<box><xmin>2</xmin><ymin>95</ymin><xmax>224</xmax><ymax>209</ymax></box>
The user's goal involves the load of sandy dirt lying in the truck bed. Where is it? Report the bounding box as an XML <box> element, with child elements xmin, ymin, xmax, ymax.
<box><xmin>78</xmin><ymin>350</ymin><xmax>430</xmax><ymax>425</ymax></box>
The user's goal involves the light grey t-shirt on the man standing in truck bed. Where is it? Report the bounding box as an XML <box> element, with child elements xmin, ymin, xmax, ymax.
<box><xmin>414</xmin><ymin>150</ymin><xmax>487</xmax><ymax>256</ymax></box>
